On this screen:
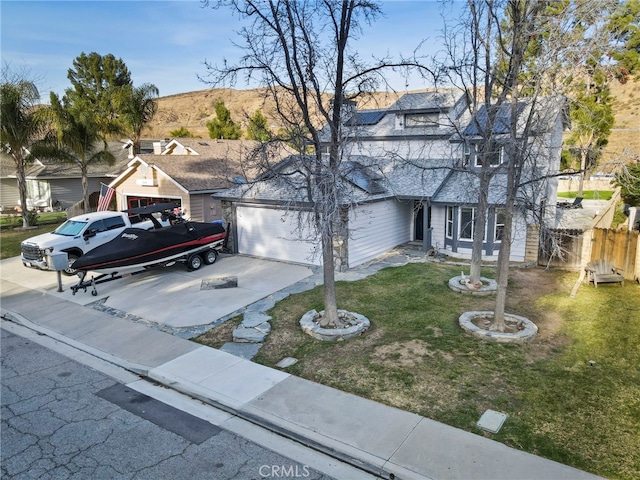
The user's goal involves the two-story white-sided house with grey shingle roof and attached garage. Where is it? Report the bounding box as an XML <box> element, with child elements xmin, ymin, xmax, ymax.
<box><xmin>215</xmin><ymin>91</ymin><xmax>564</xmax><ymax>270</ymax></box>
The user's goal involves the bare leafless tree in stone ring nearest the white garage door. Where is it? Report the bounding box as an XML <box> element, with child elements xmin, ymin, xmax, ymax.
<box><xmin>206</xmin><ymin>0</ymin><xmax>404</xmax><ymax>325</ymax></box>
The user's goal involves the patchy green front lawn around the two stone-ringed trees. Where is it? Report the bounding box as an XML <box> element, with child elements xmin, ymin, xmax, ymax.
<box><xmin>196</xmin><ymin>263</ymin><xmax>640</xmax><ymax>480</ymax></box>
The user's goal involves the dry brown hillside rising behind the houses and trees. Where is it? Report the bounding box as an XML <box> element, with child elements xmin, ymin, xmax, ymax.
<box><xmin>145</xmin><ymin>81</ymin><xmax>640</xmax><ymax>161</ymax></box>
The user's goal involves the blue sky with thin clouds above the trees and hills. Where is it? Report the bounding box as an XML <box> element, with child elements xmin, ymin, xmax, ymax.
<box><xmin>0</xmin><ymin>0</ymin><xmax>460</xmax><ymax>101</ymax></box>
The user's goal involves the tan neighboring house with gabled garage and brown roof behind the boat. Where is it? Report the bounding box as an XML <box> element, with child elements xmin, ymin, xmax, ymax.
<box><xmin>109</xmin><ymin>138</ymin><xmax>291</xmax><ymax>222</ymax></box>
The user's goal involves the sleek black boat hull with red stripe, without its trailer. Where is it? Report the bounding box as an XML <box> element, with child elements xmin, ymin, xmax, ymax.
<box><xmin>71</xmin><ymin>222</ymin><xmax>227</xmax><ymax>271</ymax></box>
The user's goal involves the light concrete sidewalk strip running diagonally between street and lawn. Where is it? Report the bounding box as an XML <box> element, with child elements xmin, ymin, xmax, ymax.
<box><xmin>0</xmin><ymin>264</ymin><xmax>600</xmax><ymax>480</ymax></box>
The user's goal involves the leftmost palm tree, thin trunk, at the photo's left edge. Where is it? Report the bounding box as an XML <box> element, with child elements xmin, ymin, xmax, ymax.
<box><xmin>0</xmin><ymin>78</ymin><xmax>46</xmax><ymax>228</ymax></box>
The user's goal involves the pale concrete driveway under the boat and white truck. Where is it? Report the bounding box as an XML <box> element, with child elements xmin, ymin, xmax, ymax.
<box><xmin>0</xmin><ymin>255</ymin><xmax>312</xmax><ymax>328</ymax></box>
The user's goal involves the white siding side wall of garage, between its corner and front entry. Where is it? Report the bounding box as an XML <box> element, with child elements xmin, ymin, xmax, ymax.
<box><xmin>348</xmin><ymin>200</ymin><xmax>413</xmax><ymax>268</ymax></box>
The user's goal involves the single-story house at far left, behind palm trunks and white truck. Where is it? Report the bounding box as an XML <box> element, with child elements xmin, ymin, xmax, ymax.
<box><xmin>0</xmin><ymin>141</ymin><xmax>128</xmax><ymax>213</ymax></box>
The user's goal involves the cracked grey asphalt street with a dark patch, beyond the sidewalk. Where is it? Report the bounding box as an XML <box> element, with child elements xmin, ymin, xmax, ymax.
<box><xmin>0</xmin><ymin>320</ymin><xmax>368</xmax><ymax>480</ymax></box>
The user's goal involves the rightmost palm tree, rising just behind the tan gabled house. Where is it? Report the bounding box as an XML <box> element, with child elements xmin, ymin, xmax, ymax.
<box><xmin>118</xmin><ymin>83</ymin><xmax>159</xmax><ymax>154</ymax></box>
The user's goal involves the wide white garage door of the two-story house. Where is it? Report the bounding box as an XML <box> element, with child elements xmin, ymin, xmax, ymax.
<box><xmin>236</xmin><ymin>207</ymin><xmax>322</xmax><ymax>265</ymax></box>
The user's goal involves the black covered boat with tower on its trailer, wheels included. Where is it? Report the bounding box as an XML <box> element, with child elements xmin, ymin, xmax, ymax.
<box><xmin>71</xmin><ymin>203</ymin><xmax>227</xmax><ymax>295</ymax></box>
